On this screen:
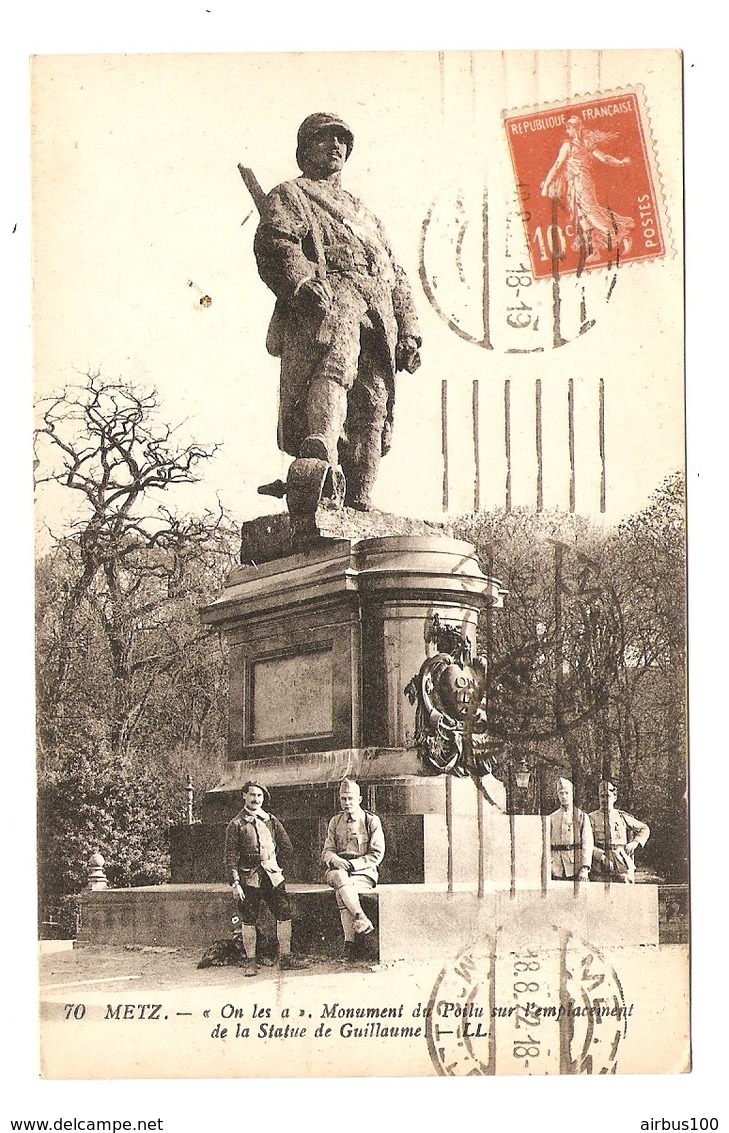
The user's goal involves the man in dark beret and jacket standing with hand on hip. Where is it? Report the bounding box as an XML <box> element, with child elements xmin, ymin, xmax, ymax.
<box><xmin>224</xmin><ymin>782</ymin><xmax>308</xmax><ymax>976</ymax></box>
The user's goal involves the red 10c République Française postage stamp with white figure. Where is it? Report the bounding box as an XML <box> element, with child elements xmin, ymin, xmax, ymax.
<box><xmin>503</xmin><ymin>90</ymin><xmax>666</xmax><ymax>279</ymax></box>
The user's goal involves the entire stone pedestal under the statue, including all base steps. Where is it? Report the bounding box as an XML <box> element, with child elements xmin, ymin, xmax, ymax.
<box><xmin>79</xmin><ymin>513</ymin><xmax>658</xmax><ymax>961</ymax></box>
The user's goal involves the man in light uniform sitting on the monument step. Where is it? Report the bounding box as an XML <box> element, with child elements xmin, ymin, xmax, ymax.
<box><xmin>322</xmin><ymin>780</ymin><xmax>384</xmax><ymax>960</ymax></box>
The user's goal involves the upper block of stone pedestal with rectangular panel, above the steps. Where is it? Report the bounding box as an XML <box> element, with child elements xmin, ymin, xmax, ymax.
<box><xmin>203</xmin><ymin>523</ymin><xmax>503</xmax><ymax>761</ymax></box>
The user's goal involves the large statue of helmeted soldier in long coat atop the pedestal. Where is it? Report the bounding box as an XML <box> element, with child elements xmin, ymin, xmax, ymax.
<box><xmin>254</xmin><ymin>113</ymin><xmax>421</xmax><ymax>511</ymax></box>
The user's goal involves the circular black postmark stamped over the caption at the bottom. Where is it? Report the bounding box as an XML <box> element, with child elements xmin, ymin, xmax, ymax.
<box><xmin>426</xmin><ymin>926</ymin><xmax>631</xmax><ymax>1076</ymax></box>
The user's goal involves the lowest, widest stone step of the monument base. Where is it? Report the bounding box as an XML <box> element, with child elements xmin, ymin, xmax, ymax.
<box><xmin>78</xmin><ymin>883</ymin><xmax>659</xmax><ymax>963</ymax></box>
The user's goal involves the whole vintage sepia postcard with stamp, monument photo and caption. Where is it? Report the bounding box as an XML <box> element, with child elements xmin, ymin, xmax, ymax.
<box><xmin>32</xmin><ymin>50</ymin><xmax>689</xmax><ymax>1083</ymax></box>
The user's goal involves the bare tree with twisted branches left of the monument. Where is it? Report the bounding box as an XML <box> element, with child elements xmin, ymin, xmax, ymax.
<box><xmin>34</xmin><ymin>372</ymin><xmax>231</xmax><ymax>751</ymax></box>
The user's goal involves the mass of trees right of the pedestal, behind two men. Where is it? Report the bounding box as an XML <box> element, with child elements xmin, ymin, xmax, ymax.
<box><xmin>458</xmin><ymin>475</ymin><xmax>687</xmax><ymax>880</ymax></box>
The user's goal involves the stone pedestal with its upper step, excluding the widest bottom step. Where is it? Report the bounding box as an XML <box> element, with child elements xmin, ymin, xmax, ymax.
<box><xmin>188</xmin><ymin>514</ymin><xmax>507</xmax><ymax>884</ymax></box>
